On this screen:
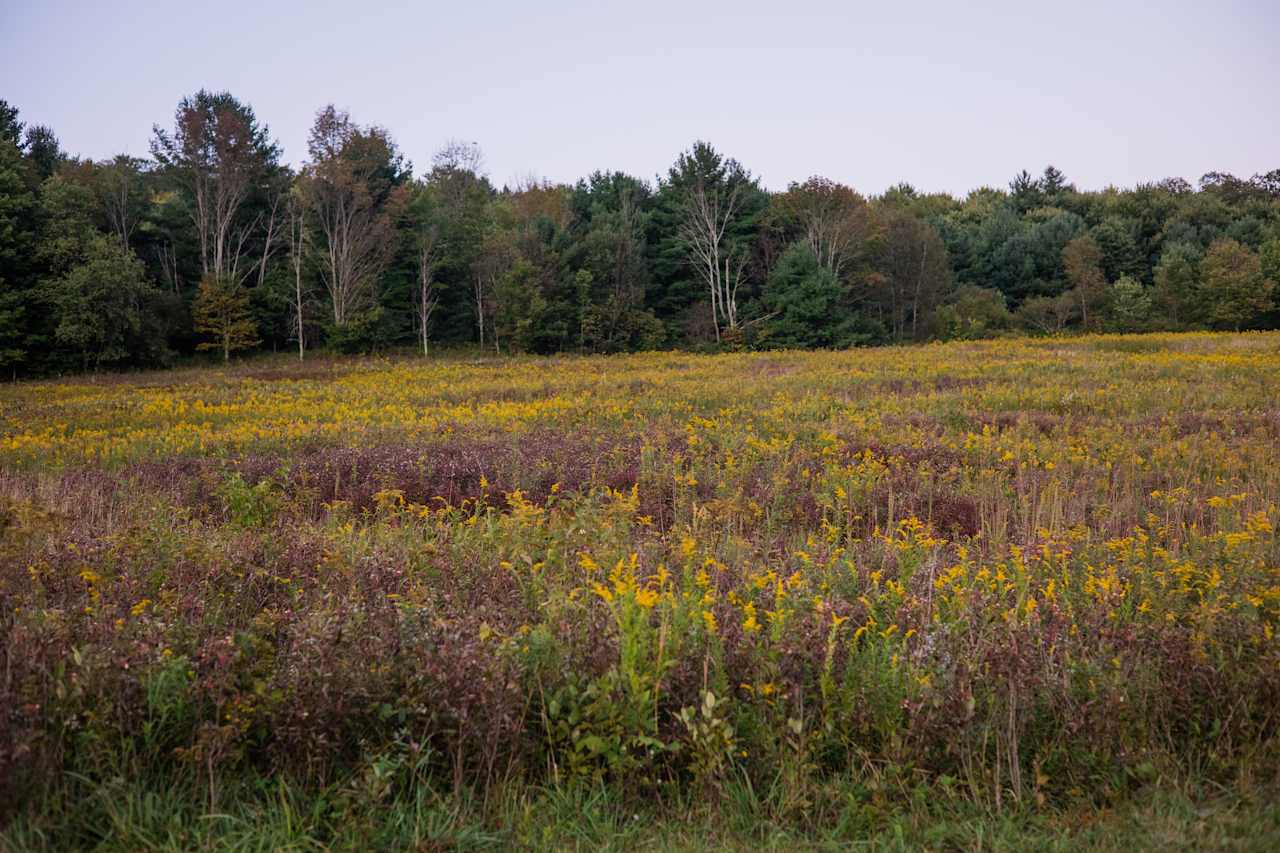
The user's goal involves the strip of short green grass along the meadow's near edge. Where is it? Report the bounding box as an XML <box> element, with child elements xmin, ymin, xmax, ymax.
<box><xmin>0</xmin><ymin>779</ymin><xmax>1280</xmax><ymax>853</ymax></box>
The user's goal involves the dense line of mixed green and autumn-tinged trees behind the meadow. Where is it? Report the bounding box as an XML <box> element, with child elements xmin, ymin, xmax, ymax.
<box><xmin>0</xmin><ymin>91</ymin><xmax>1280</xmax><ymax>375</ymax></box>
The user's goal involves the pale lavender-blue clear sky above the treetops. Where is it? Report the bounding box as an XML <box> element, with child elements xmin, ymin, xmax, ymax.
<box><xmin>0</xmin><ymin>0</ymin><xmax>1280</xmax><ymax>195</ymax></box>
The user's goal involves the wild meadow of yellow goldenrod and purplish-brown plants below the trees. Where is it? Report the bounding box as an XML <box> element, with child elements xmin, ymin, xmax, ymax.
<box><xmin>0</xmin><ymin>333</ymin><xmax>1280</xmax><ymax>850</ymax></box>
